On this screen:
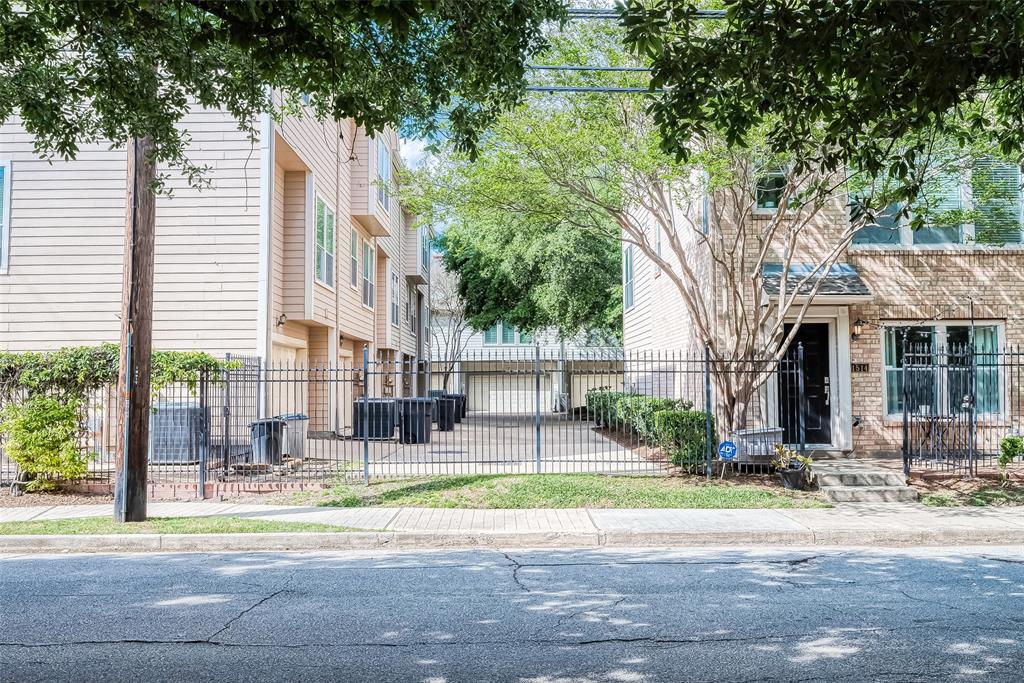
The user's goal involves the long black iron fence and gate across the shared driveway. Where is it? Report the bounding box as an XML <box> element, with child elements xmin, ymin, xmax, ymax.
<box><xmin>0</xmin><ymin>346</ymin><xmax>806</xmax><ymax>495</ymax></box>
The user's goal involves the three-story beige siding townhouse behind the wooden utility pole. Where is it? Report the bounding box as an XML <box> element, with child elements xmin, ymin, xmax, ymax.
<box><xmin>0</xmin><ymin>102</ymin><xmax>429</xmax><ymax>429</ymax></box>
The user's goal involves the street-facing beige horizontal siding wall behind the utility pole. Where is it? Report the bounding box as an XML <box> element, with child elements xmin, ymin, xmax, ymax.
<box><xmin>0</xmin><ymin>111</ymin><xmax>259</xmax><ymax>353</ymax></box>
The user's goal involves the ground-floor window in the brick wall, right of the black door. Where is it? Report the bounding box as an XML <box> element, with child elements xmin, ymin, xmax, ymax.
<box><xmin>883</xmin><ymin>323</ymin><xmax>1002</xmax><ymax>417</ymax></box>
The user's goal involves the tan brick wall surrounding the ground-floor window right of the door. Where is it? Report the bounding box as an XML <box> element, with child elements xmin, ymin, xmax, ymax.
<box><xmin>849</xmin><ymin>248</ymin><xmax>1024</xmax><ymax>453</ymax></box>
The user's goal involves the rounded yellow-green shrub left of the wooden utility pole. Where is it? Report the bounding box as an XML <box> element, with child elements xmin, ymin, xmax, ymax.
<box><xmin>0</xmin><ymin>395</ymin><xmax>89</xmax><ymax>490</ymax></box>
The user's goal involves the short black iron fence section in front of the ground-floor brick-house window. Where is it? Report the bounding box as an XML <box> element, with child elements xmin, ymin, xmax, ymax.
<box><xmin>901</xmin><ymin>340</ymin><xmax>1024</xmax><ymax>475</ymax></box>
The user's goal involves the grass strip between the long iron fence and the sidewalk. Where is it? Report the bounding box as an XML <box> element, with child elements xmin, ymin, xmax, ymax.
<box><xmin>290</xmin><ymin>474</ymin><xmax>830</xmax><ymax>509</ymax></box>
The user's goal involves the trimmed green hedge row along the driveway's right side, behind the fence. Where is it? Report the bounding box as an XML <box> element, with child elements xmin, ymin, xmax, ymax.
<box><xmin>587</xmin><ymin>389</ymin><xmax>715</xmax><ymax>469</ymax></box>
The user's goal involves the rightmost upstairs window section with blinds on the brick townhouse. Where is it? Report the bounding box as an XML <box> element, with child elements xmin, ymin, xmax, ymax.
<box><xmin>971</xmin><ymin>159</ymin><xmax>1021</xmax><ymax>245</ymax></box>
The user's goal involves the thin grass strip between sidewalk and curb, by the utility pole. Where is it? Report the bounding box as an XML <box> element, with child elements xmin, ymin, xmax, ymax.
<box><xmin>0</xmin><ymin>517</ymin><xmax>355</xmax><ymax>536</ymax></box>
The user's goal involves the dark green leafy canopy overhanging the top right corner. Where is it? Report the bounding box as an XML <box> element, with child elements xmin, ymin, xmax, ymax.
<box><xmin>622</xmin><ymin>0</ymin><xmax>1024</xmax><ymax>189</ymax></box>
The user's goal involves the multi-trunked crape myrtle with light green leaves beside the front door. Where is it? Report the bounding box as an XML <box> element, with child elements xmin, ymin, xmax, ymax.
<box><xmin>413</xmin><ymin>27</ymin><xmax>1015</xmax><ymax>430</ymax></box>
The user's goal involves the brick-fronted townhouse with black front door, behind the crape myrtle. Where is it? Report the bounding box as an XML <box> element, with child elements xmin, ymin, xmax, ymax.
<box><xmin>623</xmin><ymin>162</ymin><xmax>1024</xmax><ymax>454</ymax></box>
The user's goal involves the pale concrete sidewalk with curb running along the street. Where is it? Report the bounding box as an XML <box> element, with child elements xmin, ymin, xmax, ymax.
<box><xmin>0</xmin><ymin>502</ymin><xmax>1024</xmax><ymax>552</ymax></box>
